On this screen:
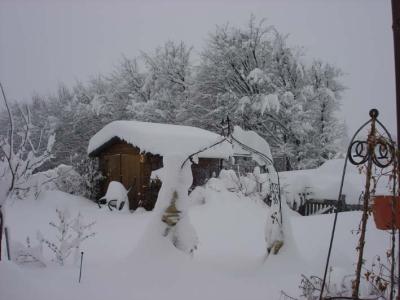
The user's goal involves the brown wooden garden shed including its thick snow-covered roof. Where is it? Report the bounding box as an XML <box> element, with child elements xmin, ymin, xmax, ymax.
<box><xmin>88</xmin><ymin>121</ymin><xmax>232</xmax><ymax>210</ymax></box>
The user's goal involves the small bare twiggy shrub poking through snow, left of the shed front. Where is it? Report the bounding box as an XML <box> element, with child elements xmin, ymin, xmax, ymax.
<box><xmin>41</xmin><ymin>209</ymin><xmax>95</xmax><ymax>266</ymax></box>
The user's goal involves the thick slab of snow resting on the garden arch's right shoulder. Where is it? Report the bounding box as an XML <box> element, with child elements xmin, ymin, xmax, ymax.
<box><xmin>232</xmin><ymin>126</ymin><xmax>273</xmax><ymax>165</ymax></box>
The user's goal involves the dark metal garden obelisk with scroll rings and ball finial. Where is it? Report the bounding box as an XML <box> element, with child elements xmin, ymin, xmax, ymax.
<box><xmin>319</xmin><ymin>109</ymin><xmax>398</xmax><ymax>300</ymax></box>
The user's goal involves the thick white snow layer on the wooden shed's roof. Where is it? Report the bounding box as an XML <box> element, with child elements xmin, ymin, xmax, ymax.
<box><xmin>87</xmin><ymin>121</ymin><xmax>233</xmax><ymax>158</ymax></box>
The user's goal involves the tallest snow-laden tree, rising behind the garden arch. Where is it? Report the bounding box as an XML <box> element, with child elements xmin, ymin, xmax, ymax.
<box><xmin>192</xmin><ymin>17</ymin><xmax>343</xmax><ymax>168</ymax></box>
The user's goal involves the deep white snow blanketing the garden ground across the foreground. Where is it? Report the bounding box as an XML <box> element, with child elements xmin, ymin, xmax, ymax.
<box><xmin>0</xmin><ymin>169</ymin><xmax>389</xmax><ymax>300</ymax></box>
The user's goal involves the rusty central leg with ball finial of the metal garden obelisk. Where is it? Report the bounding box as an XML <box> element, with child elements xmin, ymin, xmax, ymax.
<box><xmin>352</xmin><ymin>110</ymin><xmax>377</xmax><ymax>299</ymax></box>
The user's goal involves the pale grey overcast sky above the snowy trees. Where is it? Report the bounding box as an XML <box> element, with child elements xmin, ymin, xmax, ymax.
<box><xmin>0</xmin><ymin>0</ymin><xmax>395</xmax><ymax>132</ymax></box>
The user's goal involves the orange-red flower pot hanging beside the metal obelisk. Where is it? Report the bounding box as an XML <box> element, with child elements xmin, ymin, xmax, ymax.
<box><xmin>372</xmin><ymin>196</ymin><xmax>400</xmax><ymax>230</ymax></box>
